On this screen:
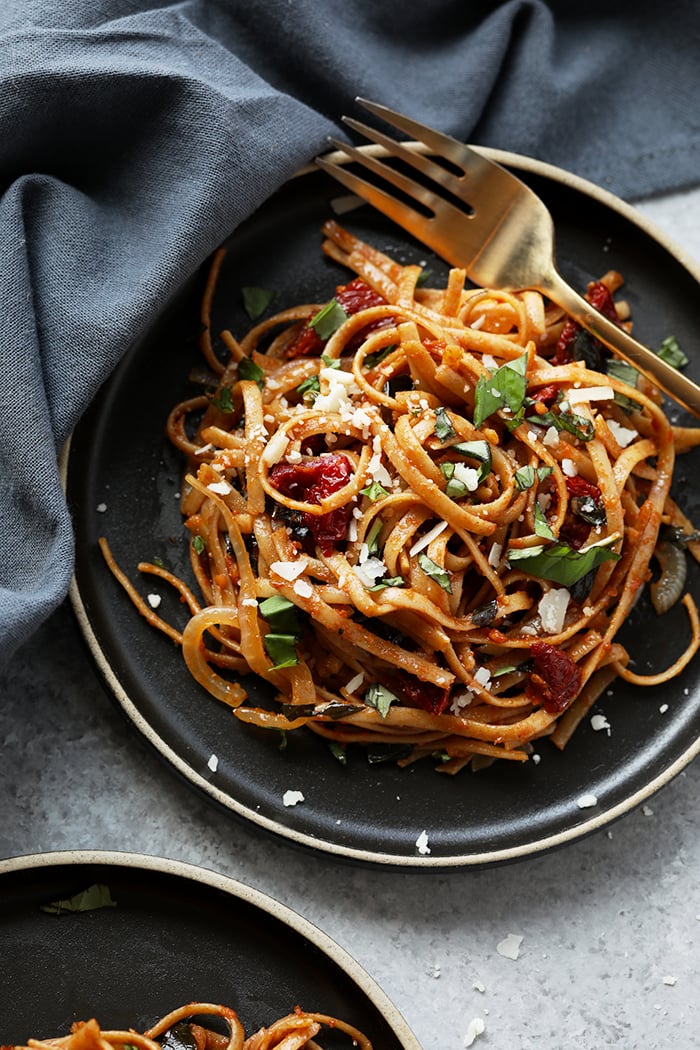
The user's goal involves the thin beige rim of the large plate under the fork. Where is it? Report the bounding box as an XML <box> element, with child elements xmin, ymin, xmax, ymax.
<box><xmin>60</xmin><ymin>148</ymin><xmax>700</xmax><ymax>874</ymax></box>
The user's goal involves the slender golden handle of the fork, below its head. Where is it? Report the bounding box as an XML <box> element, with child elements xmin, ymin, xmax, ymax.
<box><xmin>539</xmin><ymin>270</ymin><xmax>700</xmax><ymax>417</ymax></box>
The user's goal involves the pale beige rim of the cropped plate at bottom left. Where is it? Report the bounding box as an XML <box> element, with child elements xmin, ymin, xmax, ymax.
<box><xmin>0</xmin><ymin>849</ymin><xmax>423</xmax><ymax>1050</ymax></box>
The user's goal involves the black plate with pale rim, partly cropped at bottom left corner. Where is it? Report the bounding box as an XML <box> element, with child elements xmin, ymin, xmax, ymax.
<box><xmin>0</xmin><ymin>853</ymin><xmax>420</xmax><ymax>1050</ymax></box>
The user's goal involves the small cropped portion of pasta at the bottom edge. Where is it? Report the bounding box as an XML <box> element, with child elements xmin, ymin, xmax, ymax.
<box><xmin>16</xmin><ymin>1003</ymin><xmax>372</xmax><ymax>1050</ymax></box>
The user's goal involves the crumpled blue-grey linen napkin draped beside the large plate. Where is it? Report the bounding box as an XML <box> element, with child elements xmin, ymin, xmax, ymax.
<box><xmin>0</xmin><ymin>0</ymin><xmax>700</xmax><ymax>664</ymax></box>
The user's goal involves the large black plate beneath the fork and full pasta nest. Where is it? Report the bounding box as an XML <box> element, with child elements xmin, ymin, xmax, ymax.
<box><xmin>67</xmin><ymin>154</ymin><xmax>700</xmax><ymax>868</ymax></box>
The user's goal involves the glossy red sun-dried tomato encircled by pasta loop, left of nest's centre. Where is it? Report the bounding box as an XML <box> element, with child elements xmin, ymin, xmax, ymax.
<box><xmin>269</xmin><ymin>456</ymin><xmax>353</xmax><ymax>554</ymax></box>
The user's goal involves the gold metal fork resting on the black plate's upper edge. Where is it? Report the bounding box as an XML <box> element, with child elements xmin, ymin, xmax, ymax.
<box><xmin>316</xmin><ymin>99</ymin><xmax>700</xmax><ymax>416</ymax></box>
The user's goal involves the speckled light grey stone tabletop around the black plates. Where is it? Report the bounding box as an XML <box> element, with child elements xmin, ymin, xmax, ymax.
<box><xmin>0</xmin><ymin>190</ymin><xmax>700</xmax><ymax>1050</ymax></box>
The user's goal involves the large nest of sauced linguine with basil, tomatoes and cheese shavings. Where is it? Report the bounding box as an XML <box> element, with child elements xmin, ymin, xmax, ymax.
<box><xmin>101</xmin><ymin>222</ymin><xmax>700</xmax><ymax>773</ymax></box>
